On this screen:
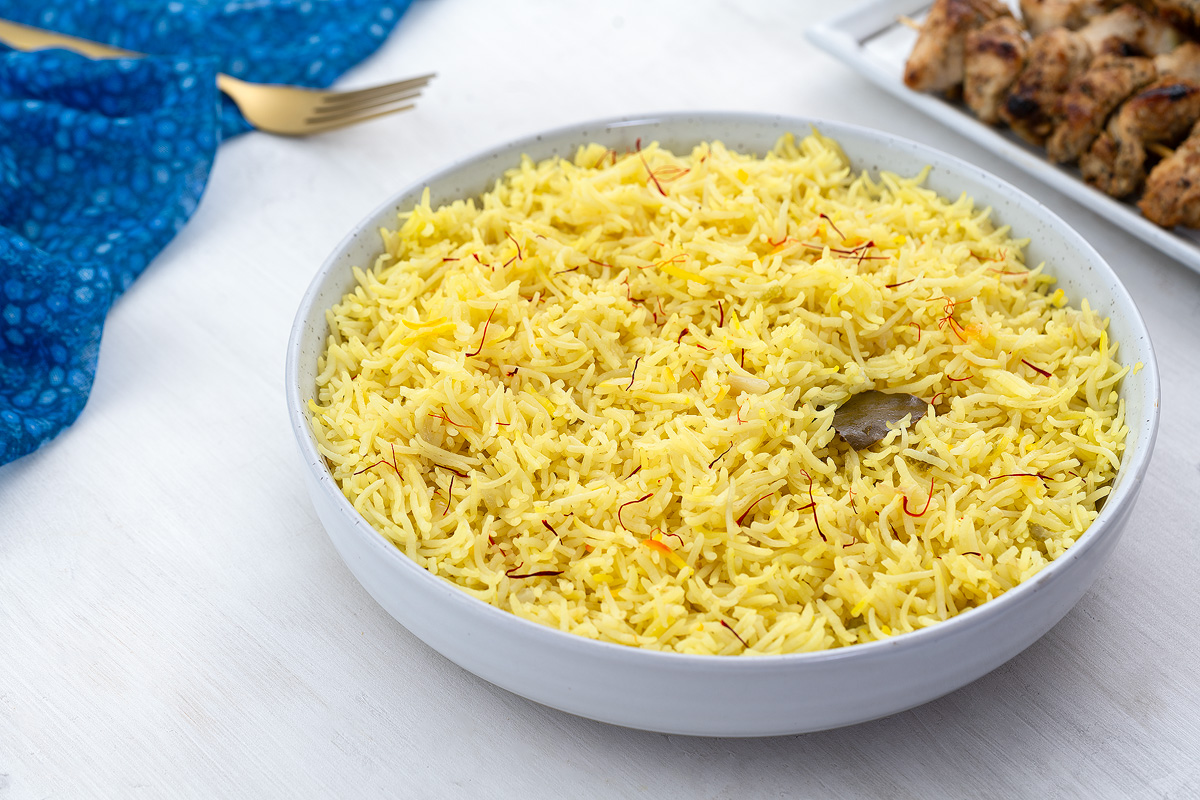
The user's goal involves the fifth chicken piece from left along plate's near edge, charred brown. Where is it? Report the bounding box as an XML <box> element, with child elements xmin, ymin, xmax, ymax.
<box><xmin>1079</xmin><ymin>78</ymin><xmax>1200</xmax><ymax>198</ymax></box>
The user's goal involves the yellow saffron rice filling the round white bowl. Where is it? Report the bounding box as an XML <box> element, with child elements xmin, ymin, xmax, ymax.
<box><xmin>311</xmin><ymin>134</ymin><xmax>1127</xmax><ymax>655</ymax></box>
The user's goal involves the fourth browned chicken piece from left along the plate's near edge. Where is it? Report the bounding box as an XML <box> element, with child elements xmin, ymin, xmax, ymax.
<box><xmin>1046</xmin><ymin>55</ymin><xmax>1158</xmax><ymax>163</ymax></box>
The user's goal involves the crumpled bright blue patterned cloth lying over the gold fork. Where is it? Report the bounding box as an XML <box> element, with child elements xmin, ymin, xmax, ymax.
<box><xmin>0</xmin><ymin>0</ymin><xmax>409</xmax><ymax>464</ymax></box>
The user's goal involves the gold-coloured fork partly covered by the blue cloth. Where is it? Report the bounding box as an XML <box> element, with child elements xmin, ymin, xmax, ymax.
<box><xmin>0</xmin><ymin>19</ymin><xmax>433</xmax><ymax>136</ymax></box>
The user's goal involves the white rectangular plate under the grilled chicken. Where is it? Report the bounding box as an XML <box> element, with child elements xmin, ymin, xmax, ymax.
<box><xmin>808</xmin><ymin>0</ymin><xmax>1200</xmax><ymax>271</ymax></box>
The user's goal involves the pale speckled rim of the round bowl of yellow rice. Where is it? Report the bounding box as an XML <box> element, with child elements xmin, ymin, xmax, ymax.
<box><xmin>284</xmin><ymin>110</ymin><xmax>1162</xmax><ymax>673</ymax></box>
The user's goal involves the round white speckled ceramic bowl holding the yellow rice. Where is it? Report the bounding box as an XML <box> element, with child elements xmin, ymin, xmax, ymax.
<box><xmin>286</xmin><ymin>113</ymin><xmax>1159</xmax><ymax>736</ymax></box>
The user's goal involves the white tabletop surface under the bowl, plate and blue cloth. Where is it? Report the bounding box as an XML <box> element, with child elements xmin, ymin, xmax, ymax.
<box><xmin>0</xmin><ymin>0</ymin><xmax>1200</xmax><ymax>800</ymax></box>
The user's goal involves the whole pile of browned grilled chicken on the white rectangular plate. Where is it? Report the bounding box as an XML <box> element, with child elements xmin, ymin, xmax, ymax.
<box><xmin>905</xmin><ymin>0</ymin><xmax>1200</xmax><ymax>225</ymax></box>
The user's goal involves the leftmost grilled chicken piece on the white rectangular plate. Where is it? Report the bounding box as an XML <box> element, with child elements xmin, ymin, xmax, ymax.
<box><xmin>904</xmin><ymin>0</ymin><xmax>1013</xmax><ymax>91</ymax></box>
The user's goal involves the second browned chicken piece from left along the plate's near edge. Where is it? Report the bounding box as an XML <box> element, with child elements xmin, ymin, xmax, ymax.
<box><xmin>962</xmin><ymin>17</ymin><xmax>1030</xmax><ymax>125</ymax></box>
